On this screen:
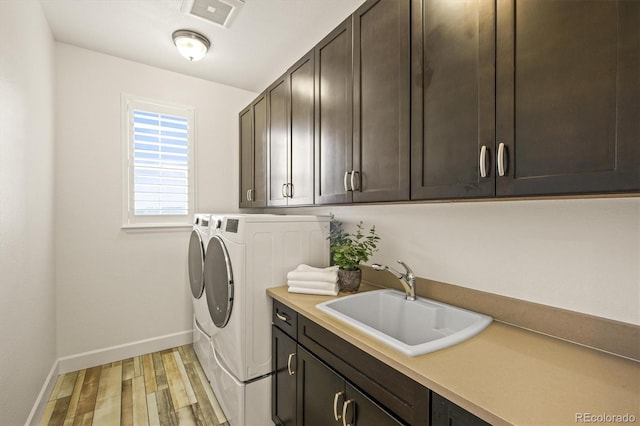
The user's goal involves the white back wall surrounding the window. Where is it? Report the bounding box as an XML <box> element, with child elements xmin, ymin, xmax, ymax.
<box><xmin>56</xmin><ymin>43</ymin><xmax>254</xmax><ymax>358</ymax></box>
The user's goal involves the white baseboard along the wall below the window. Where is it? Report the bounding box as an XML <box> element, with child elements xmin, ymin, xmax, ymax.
<box><xmin>58</xmin><ymin>330</ymin><xmax>193</xmax><ymax>374</ymax></box>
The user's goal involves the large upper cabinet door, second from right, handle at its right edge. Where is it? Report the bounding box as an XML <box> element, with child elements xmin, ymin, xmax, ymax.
<box><xmin>411</xmin><ymin>0</ymin><xmax>496</xmax><ymax>200</ymax></box>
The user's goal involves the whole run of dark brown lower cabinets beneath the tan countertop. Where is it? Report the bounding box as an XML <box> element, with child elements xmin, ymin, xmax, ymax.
<box><xmin>272</xmin><ymin>301</ymin><xmax>488</xmax><ymax>426</ymax></box>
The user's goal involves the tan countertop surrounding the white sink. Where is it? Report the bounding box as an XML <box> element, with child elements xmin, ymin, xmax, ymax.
<box><xmin>267</xmin><ymin>283</ymin><xmax>640</xmax><ymax>426</ymax></box>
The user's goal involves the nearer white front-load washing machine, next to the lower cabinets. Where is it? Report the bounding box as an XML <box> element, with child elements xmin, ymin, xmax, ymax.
<box><xmin>196</xmin><ymin>214</ymin><xmax>329</xmax><ymax>426</ymax></box>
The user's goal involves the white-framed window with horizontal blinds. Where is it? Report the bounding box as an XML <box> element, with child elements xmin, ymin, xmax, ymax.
<box><xmin>122</xmin><ymin>95</ymin><xmax>195</xmax><ymax>227</ymax></box>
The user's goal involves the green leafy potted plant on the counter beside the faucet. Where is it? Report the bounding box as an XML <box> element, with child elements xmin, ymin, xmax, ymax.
<box><xmin>329</xmin><ymin>216</ymin><xmax>380</xmax><ymax>293</ymax></box>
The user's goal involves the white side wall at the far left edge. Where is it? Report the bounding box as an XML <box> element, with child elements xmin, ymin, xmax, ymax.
<box><xmin>0</xmin><ymin>1</ymin><xmax>56</xmax><ymax>425</ymax></box>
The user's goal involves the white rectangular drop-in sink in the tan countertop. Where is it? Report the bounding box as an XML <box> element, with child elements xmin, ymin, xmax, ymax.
<box><xmin>316</xmin><ymin>290</ymin><xmax>493</xmax><ymax>356</ymax></box>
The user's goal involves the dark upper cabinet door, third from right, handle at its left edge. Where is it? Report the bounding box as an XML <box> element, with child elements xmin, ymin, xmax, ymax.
<box><xmin>352</xmin><ymin>0</ymin><xmax>411</xmax><ymax>202</ymax></box>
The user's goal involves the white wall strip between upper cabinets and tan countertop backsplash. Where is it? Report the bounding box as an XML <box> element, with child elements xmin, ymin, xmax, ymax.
<box><xmin>288</xmin><ymin>198</ymin><xmax>640</xmax><ymax>325</ymax></box>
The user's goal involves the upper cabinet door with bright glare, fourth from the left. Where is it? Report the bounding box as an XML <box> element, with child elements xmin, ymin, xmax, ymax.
<box><xmin>288</xmin><ymin>52</ymin><xmax>315</xmax><ymax>206</ymax></box>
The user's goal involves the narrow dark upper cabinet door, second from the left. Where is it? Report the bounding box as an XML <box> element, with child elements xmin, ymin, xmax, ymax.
<box><xmin>251</xmin><ymin>93</ymin><xmax>267</xmax><ymax>207</ymax></box>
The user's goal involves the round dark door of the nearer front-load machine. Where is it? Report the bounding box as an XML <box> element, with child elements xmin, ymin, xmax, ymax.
<box><xmin>204</xmin><ymin>235</ymin><xmax>233</xmax><ymax>328</ymax></box>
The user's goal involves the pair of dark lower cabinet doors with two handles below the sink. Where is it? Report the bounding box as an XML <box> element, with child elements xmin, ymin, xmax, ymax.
<box><xmin>297</xmin><ymin>347</ymin><xmax>403</xmax><ymax>426</ymax></box>
